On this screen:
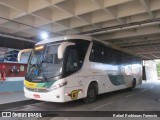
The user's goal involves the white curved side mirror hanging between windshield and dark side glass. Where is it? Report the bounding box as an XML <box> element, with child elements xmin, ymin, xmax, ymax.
<box><xmin>58</xmin><ymin>42</ymin><xmax>75</xmax><ymax>59</ymax></box>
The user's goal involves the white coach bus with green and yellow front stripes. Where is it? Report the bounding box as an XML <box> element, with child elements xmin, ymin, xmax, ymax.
<box><xmin>18</xmin><ymin>35</ymin><xmax>142</xmax><ymax>103</ymax></box>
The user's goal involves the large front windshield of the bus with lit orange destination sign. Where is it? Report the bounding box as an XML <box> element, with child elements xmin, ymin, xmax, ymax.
<box><xmin>26</xmin><ymin>44</ymin><xmax>63</xmax><ymax>82</ymax></box>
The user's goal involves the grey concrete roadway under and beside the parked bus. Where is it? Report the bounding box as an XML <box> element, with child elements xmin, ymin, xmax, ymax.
<box><xmin>0</xmin><ymin>81</ymin><xmax>160</xmax><ymax>120</ymax></box>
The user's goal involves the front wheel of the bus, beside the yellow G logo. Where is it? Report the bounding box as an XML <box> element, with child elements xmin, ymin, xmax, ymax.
<box><xmin>83</xmin><ymin>82</ymin><xmax>98</xmax><ymax>103</ymax></box>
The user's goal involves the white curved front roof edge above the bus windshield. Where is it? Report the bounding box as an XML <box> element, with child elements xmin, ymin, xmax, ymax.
<box><xmin>36</xmin><ymin>35</ymin><xmax>92</xmax><ymax>45</ymax></box>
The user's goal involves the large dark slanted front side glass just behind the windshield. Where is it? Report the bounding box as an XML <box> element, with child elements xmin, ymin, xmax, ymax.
<box><xmin>63</xmin><ymin>40</ymin><xmax>90</xmax><ymax>77</ymax></box>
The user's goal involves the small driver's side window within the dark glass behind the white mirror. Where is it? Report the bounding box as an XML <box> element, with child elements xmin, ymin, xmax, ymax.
<box><xmin>66</xmin><ymin>50</ymin><xmax>79</xmax><ymax>74</ymax></box>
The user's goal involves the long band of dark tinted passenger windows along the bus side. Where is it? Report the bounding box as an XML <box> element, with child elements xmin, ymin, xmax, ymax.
<box><xmin>89</xmin><ymin>41</ymin><xmax>140</xmax><ymax>65</ymax></box>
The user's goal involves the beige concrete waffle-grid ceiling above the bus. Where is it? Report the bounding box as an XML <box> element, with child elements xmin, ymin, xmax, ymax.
<box><xmin>0</xmin><ymin>0</ymin><xmax>160</xmax><ymax>59</ymax></box>
